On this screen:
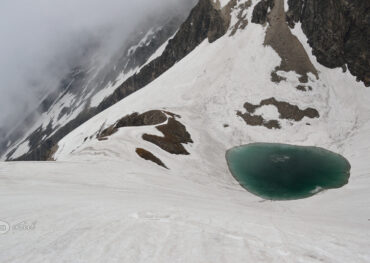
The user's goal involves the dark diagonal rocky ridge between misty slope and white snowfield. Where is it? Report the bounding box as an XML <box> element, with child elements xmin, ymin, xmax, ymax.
<box><xmin>7</xmin><ymin>0</ymin><xmax>228</xmax><ymax>160</ymax></box>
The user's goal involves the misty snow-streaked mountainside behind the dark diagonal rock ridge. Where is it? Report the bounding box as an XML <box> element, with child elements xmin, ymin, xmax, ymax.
<box><xmin>0</xmin><ymin>14</ymin><xmax>188</xmax><ymax>160</ymax></box>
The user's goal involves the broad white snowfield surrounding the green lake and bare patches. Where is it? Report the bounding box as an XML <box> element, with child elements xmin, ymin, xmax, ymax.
<box><xmin>0</xmin><ymin>1</ymin><xmax>370</xmax><ymax>263</ymax></box>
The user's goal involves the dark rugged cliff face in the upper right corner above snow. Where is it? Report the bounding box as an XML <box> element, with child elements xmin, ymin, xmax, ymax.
<box><xmin>287</xmin><ymin>0</ymin><xmax>370</xmax><ymax>86</ymax></box>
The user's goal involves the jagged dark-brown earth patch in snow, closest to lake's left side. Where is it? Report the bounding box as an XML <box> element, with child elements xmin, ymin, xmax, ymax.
<box><xmin>143</xmin><ymin>118</ymin><xmax>193</xmax><ymax>155</ymax></box>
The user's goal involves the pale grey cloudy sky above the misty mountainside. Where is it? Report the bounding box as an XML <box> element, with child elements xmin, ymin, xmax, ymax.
<box><xmin>0</xmin><ymin>0</ymin><xmax>193</xmax><ymax>132</ymax></box>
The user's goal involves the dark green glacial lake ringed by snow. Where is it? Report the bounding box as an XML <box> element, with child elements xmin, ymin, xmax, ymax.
<box><xmin>226</xmin><ymin>143</ymin><xmax>351</xmax><ymax>200</ymax></box>
